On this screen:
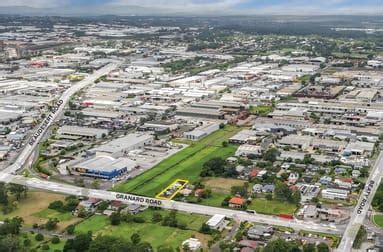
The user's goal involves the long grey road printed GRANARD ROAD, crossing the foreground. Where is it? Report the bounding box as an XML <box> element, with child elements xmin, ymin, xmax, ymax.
<box><xmin>0</xmin><ymin>173</ymin><xmax>343</xmax><ymax>235</ymax></box>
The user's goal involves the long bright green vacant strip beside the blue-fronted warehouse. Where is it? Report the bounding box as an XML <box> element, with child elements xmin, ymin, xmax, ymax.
<box><xmin>116</xmin><ymin>125</ymin><xmax>241</xmax><ymax>197</ymax></box>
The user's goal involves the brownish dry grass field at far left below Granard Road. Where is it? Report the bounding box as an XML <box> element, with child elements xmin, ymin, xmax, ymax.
<box><xmin>0</xmin><ymin>191</ymin><xmax>78</xmax><ymax>230</ymax></box>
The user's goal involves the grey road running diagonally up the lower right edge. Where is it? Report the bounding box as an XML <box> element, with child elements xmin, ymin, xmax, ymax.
<box><xmin>337</xmin><ymin>151</ymin><xmax>383</xmax><ymax>252</ymax></box>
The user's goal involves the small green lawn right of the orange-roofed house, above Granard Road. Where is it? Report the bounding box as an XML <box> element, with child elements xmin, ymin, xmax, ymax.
<box><xmin>247</xmin><ymin>198</ymin><xmax>297</xmax><ymax>215</ymax></box>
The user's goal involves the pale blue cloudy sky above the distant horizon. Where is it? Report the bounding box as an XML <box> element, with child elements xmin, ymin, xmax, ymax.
<box><xmin>0</xmin><ymin>0</ymin><xmax>383</xmax><ymax>16</ymax></box>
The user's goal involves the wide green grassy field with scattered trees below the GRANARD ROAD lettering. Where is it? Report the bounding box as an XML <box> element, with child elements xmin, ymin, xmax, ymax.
<box><xmin>76</xmin><ymin>210</ymin><xmax>210</xmax><ymax>248</ymax></box>
